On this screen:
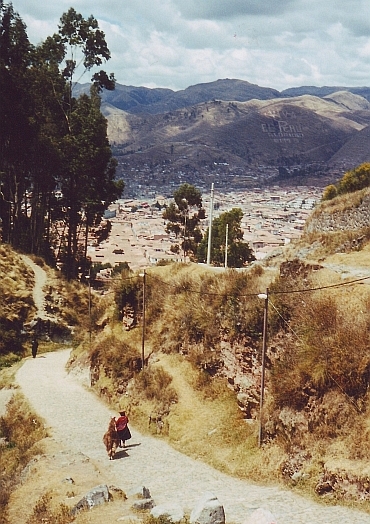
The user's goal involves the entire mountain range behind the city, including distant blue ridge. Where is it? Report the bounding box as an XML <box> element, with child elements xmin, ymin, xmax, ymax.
<box><xmin>79</xmin><ymin>79</ymin><xmax>370</xmax><ymax>184</ymax></box>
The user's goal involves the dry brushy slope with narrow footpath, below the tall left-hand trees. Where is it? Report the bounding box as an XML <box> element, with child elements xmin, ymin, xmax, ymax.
<box><xmin>0</xmin><ymin>250</ymin><xmax>90</xmax><ymax>372</ymax></box>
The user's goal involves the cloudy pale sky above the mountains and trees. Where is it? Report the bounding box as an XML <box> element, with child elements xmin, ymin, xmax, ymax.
<box><xmin>11</xmin><ymin>0</ymin><xmax>370</xmax><ymax>91</ymax></box>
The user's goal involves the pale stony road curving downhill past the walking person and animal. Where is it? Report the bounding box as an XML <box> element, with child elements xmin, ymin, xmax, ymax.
<box><xmin>16</xmin><ymin>350</ymin><xmax>370</xmax><ymax>524</ymax></box>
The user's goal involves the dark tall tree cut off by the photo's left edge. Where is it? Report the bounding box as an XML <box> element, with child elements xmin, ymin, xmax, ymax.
<box><xmin>0</xmin><ymin>2</ymin><xmax>35</xmax><ymax>243</ymax></box>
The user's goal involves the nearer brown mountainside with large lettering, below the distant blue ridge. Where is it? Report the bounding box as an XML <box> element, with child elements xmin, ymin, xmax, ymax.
<box><xmin>108</xmin><ymin>93</ymin><xmax>370</xmax><ymax>176</ymax></box>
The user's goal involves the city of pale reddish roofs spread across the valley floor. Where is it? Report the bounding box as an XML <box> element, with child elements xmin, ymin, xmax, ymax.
<box><xmin>88</xmin><ymin>186</ymin><xmax>323</xmax><ymax>276</ymax></box>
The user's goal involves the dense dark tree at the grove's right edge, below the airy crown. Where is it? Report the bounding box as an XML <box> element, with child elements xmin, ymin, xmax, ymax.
<box><xmin>61</xmin><ymin>90</ymin><xmax>123</xmax><ymax>276</ymax></box>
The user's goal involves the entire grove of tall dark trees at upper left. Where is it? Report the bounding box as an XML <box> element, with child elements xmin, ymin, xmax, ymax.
<box><xmin>0</xmin><ymin>3</ymin><xmax>123</xmax><ymax>278</ymax></box>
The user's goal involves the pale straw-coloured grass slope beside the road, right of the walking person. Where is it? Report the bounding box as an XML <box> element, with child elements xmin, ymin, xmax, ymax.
<box><xmin>129</xmin><ymin>354</ymin><xmax>272</xmax><ymax>480</ymax></box>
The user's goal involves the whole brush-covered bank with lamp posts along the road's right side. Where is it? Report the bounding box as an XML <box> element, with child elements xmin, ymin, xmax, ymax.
<box><xmin>68</xmin><ymin>244</ymin><xmax>362</xmax><ymax>507</ymax></box>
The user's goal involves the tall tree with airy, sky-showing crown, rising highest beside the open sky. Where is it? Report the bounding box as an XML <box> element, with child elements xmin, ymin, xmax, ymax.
<box><xmin>37</xmin><ymin>8</ymin><xmax>118</xmax><ymax>278</ymax></box>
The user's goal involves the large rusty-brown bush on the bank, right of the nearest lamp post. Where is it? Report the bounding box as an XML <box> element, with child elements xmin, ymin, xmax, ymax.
<box><xmin>271</xmin><ymin>282</ymin><xmax>370</xmax><ymax>409</ymax></box>
